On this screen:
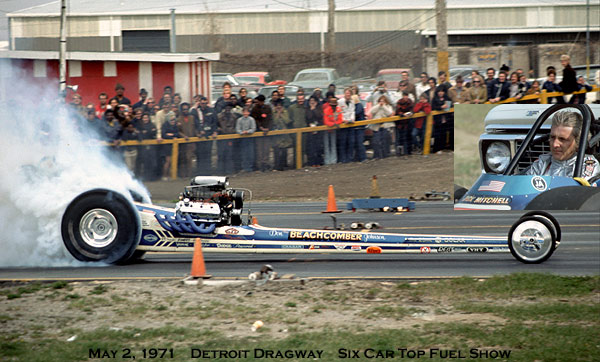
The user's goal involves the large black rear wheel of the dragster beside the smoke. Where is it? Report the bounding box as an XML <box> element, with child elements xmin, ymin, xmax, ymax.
<box><xmin>61</xmin><ymin>189</ymin><xmax>141</xmax><ymax>264</ymax></box>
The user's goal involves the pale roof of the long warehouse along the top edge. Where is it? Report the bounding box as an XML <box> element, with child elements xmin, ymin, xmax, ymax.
<box><xmin>8</xmin><ymin>0</ymin><xmax>586</xmax><ymax>17</ymax></box>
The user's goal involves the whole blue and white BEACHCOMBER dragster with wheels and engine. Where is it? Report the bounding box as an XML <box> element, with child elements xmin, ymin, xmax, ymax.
<box><xmin>61</xmin><ymin>176</ymin><xmax>561</xmax><ymax>263</ymax></box>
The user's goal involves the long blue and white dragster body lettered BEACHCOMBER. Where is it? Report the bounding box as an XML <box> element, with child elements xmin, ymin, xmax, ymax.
<box><xmin>136</xmin><ymin>203</ymin><xmax>508</xmax><ymax>254</ymax></box>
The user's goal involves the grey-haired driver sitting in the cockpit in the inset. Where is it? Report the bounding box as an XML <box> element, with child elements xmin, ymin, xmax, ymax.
<box><xmin>526</xmin><ymin>111</ymin><xmax>600</xmax><ymax>181</ymax></box>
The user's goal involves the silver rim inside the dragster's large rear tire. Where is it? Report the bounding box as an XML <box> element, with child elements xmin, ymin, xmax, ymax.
<box><xmin>79</xmin><ymin>209</ymin><xmax>119</xmax><ymax>248</ymax></box>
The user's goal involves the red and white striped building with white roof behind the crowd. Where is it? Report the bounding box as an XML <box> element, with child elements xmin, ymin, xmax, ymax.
<box><xmin>0</xmin><ymin>51</ymin><xmax>219</xmax><ymax>105</ymax></box>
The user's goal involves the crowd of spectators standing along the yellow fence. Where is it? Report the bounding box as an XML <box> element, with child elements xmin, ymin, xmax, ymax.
<box><xmin>71</xmin><ymin>56</ymin><xmax>591</xmax><ymax>180</ymax></box>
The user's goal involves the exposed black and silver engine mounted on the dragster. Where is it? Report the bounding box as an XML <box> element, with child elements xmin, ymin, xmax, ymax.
<box><xmin>175</xmin><ymin>176</ymin><xmax>244</xmax><ymax>226</ymax></box>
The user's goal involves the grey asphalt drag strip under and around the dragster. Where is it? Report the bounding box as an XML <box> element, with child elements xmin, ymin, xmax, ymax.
<box><xmin>0</xmin><ymin>202</ymin><xmax>600</xmax><ymax>280</ymax></box>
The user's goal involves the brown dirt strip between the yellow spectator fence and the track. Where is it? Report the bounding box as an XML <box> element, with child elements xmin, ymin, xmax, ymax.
<box><xmin>146</xmin><ymin>152</ymin><xmax>454</xmax><ymax>201</ymax></box>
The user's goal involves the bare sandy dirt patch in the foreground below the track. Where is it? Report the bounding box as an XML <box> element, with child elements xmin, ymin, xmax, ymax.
<box><xmin>0</xmin><ymin>280</ymin><xmax>505</xmax><ymax>340</ymax></box>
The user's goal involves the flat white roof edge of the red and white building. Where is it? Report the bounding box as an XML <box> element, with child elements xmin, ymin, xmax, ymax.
<box><xmin>0</xmin><ymin>50</ymin><xmax>220</xmax><ymax>63</ymax></box>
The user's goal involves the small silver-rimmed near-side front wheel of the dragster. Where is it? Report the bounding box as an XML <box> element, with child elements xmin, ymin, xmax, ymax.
<box><xmin>508</xmin><ymin>216</ymin><xmax>557</xmax><ymax>264</ymax></box>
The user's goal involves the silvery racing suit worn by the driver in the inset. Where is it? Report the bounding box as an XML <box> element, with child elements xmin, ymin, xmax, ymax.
<box><xmin>525</xmin><ymin>153</ymin><xmax>600</xmax><ymax>181</ymax></box>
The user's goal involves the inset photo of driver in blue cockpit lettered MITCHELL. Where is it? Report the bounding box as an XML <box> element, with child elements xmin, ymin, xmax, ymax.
<box><xmin>454</xmin><ymin>104</ymin><xmax>600</xmax><ymax>211</ymax></box>
